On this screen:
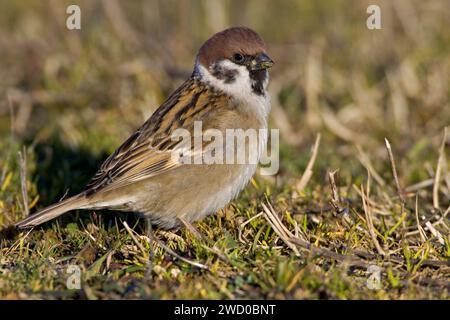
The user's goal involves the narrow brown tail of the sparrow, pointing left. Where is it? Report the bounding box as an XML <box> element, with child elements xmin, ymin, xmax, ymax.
<box><xmin>15</xmin><ymin>194</ymin><xmax>88</xmax><ymax>228</ymax></box>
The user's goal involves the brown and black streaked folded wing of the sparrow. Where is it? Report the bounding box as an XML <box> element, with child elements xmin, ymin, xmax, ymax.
<box><xmin>85</xmin><ymin>77</ymin><xmax>227</xmax><ymax>195</ymax></box>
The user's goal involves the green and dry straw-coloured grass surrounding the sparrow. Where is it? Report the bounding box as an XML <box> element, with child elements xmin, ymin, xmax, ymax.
<box><xmin>0</xmin><ymin>1</ymin><xmax>450</xmax><ymax>299</ymax></box>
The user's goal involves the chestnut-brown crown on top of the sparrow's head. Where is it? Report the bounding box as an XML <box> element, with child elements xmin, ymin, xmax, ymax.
<box><xmin>198</xmin><ymin>27</ymin><xmax>266</xmax><ymax>68</ymax></box>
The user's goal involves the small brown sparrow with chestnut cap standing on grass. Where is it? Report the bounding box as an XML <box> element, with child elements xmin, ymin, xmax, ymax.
<box><xmin>16</xmin><ymin>27</ymin><xmax>273</xmax><ymax>228</ymax></box>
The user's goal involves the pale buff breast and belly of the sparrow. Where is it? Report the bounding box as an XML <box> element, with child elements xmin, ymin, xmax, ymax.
<box><xmin>135</xmin><ymin>99</ymin><xmax>267</xmax><ymax>228</ymax></box>
